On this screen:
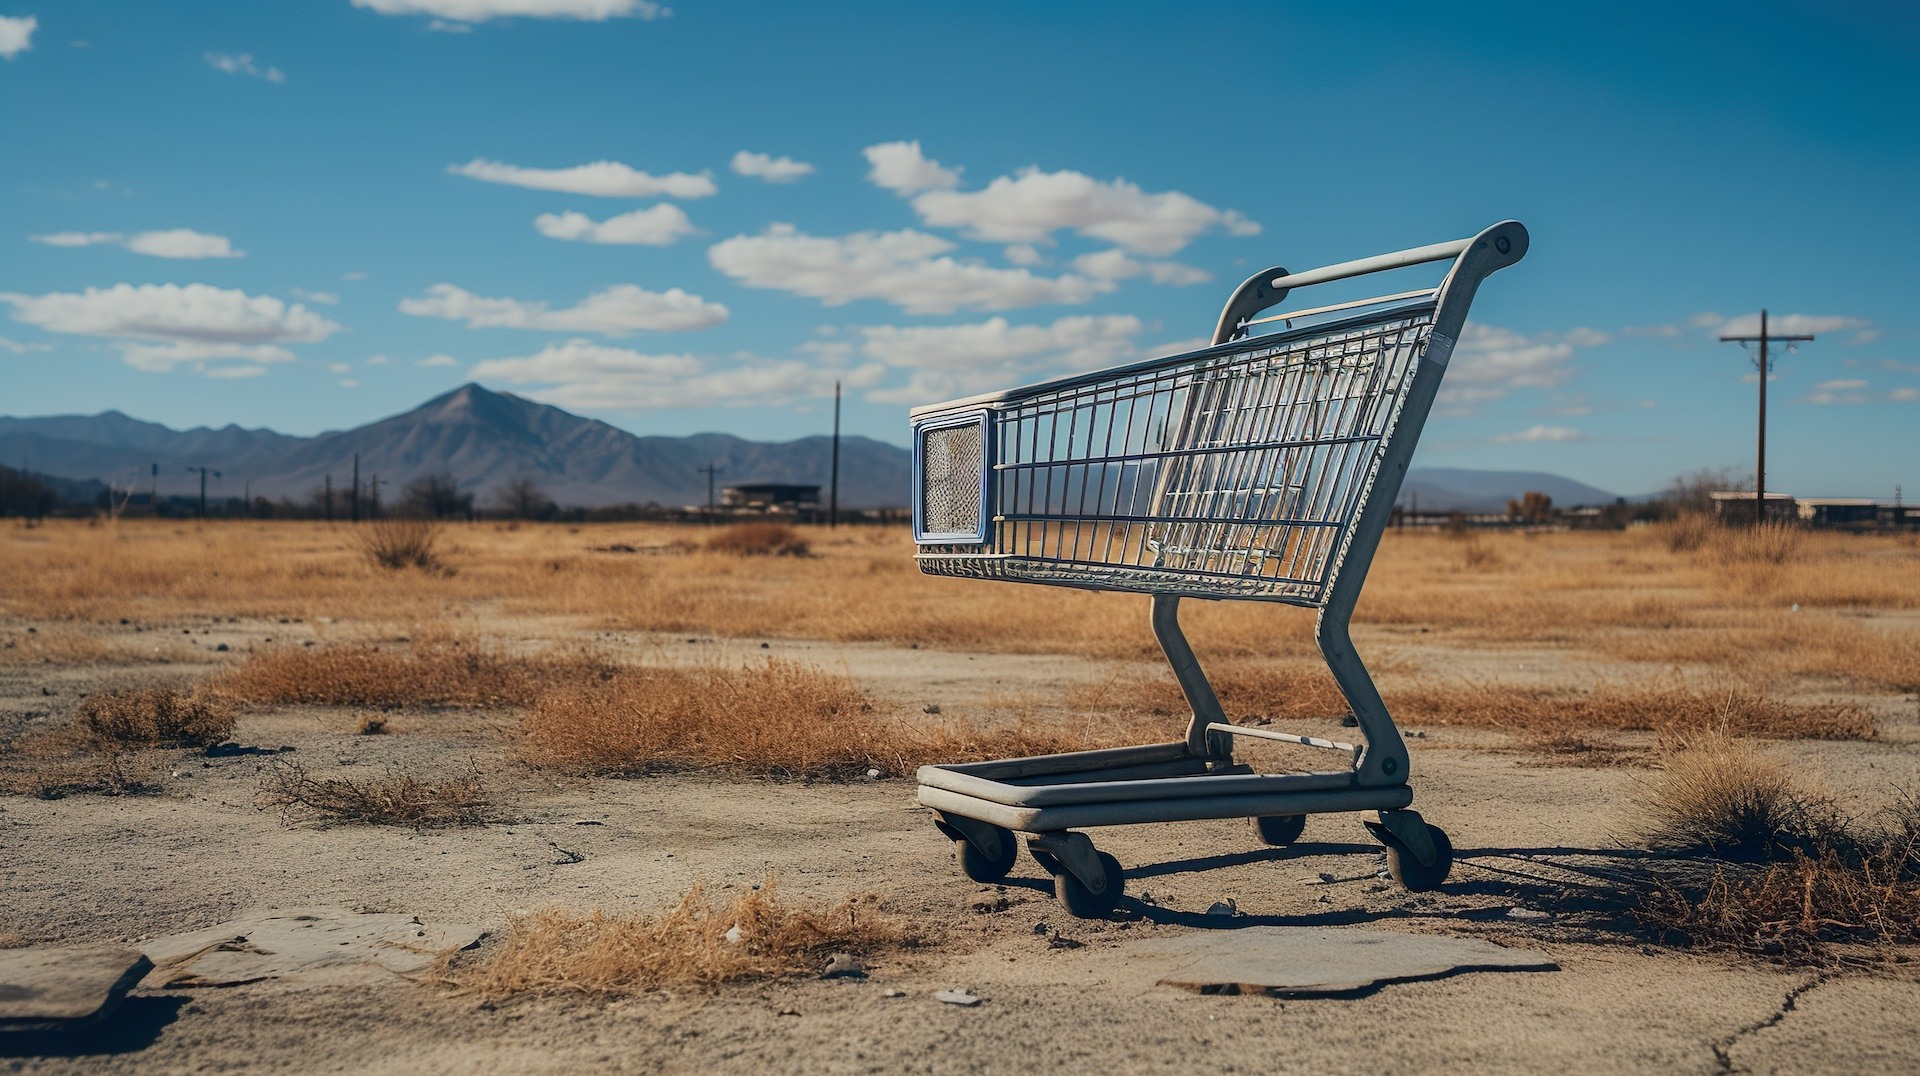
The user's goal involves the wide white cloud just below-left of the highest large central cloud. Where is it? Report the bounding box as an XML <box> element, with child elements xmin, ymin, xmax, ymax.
<box><xmin>707</xmin><ymin>225</ymin><xmax>1114</xmax><ymax>313</ymax></box>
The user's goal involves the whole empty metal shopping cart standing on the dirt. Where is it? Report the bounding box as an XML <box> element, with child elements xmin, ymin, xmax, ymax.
<box><xmin>912</xmin><ymin>221</ymin><xmax>1526</xmax><ymax>917</ymax></box>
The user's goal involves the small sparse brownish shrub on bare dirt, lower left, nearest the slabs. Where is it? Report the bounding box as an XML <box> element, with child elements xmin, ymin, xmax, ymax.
<box><xmin>259</xmin><ymin>761</ymin><xmax>493</xmax><ymax>830</ymax></box>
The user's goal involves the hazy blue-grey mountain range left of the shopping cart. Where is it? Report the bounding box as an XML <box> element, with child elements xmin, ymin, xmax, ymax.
<box><xmin>0</xmin><ymin>384</ymin><xmax>912</xmax><ymax>507</ymax></box>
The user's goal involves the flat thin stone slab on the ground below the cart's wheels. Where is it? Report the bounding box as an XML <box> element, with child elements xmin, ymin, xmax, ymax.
<box><xmin>1129</xmin><ymin>926</ymin><xmax>1559</xmax><ymax>997</ymax></box>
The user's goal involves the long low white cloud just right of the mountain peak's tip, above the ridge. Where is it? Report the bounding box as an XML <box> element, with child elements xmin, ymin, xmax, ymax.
<box><xmin>470</xmin><ymin>340</ymin><xmax>885</xmax><ymax>411</ymax></box>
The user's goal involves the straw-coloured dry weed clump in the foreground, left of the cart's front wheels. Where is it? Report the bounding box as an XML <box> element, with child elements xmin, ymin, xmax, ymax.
<box><xmin>444</xmin><ymin>880</ymin><xmax>912</xmax><ymax>999</ymax></box>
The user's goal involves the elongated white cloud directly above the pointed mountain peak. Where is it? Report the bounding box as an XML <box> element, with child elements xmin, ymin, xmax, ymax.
<box><xmin>399</xmin><ymin>284</ymin><xmax>728</xmax><ymax>336</ymax></box>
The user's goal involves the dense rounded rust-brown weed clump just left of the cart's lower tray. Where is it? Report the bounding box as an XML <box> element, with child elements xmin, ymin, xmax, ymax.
<box><xmin>520</xmin><ymin>659</ymin><xmax>891</xmax><ymax>778</ymax></box>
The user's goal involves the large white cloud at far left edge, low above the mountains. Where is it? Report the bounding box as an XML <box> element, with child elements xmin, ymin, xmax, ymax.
<box><xmin>0</xmin><ymin>284</ymin><xmax>340</xmax><ymax>371</ymax></box>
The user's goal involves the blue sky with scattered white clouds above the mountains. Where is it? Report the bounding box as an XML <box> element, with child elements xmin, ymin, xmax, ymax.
<box><xmin>0</xmin><ymin>0</ymin><xmax>1920</xmax><ymax>500</ymax></box>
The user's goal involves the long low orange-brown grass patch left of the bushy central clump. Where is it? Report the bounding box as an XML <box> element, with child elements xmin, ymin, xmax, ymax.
<box><xmin>213</xmin><ymin>636</ymin><xmax>612</xmax><ymax>709</ymax></box>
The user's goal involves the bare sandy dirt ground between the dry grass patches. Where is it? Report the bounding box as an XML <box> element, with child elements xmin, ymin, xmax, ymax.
<box><xmin>0</xmin><ymin>624</ymin><xmax>1920</xmax><ymax>1072</ymax></box>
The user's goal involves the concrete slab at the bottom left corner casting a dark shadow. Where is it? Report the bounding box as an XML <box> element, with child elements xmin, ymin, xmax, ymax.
<box><xmin>0</xmin><ymin>945</ymin><xmax>154</xmax><ymax>1032</ymax></box>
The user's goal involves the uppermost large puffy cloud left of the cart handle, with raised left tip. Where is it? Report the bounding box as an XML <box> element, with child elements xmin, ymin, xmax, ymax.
<box><xmin>890</xmin><ymin>151</ymin><xmax>1260</xmax><ymax>256</ymax></box>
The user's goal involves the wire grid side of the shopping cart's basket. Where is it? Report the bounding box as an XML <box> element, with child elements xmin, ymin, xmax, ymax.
<box><xmin>920</xmin><ymin>302</ymin><xmax>1434</xmax><ymax>605</ymax></box>
